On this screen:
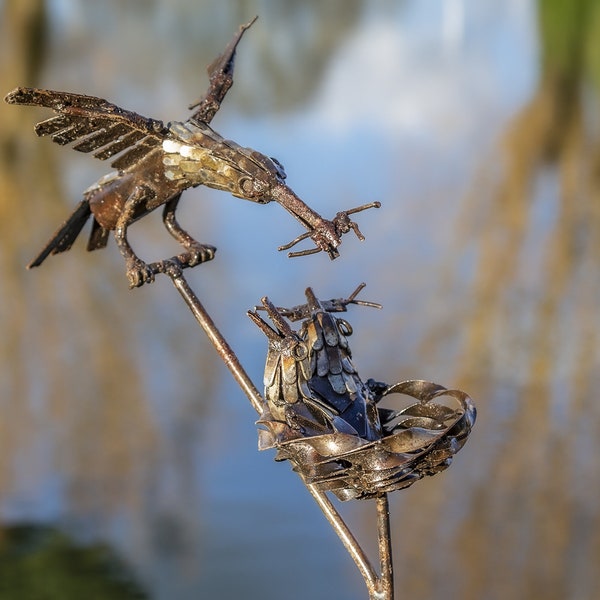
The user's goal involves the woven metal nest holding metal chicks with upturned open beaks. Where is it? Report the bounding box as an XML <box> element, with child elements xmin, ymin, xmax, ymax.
<box><xmin>248</xmin><ymin>286</ymin><xmax>476</xmax><ymax>500</ymax></box>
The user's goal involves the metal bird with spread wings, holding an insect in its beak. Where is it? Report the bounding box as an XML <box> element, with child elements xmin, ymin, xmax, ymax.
<box><xmin>5</xmin><ymin>18</ymin><xmax>379</xmax><ymax>287</ymax></box>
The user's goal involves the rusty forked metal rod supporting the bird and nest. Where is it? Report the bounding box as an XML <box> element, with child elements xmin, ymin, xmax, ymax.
<box><xmin>164</xmin><ymin>262</ymin><xmax>394</xmax><ymax>600</ymax></box>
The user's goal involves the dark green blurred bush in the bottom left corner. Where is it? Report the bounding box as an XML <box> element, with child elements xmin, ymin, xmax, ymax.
<box><xmin>0</xmin><ymin>525</ymin><xmax>148</xmax><ymax>600</ymax></box>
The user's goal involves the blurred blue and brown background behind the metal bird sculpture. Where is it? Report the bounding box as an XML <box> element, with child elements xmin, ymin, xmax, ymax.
<box><xmin>0</xmin><ymin>0</ymin><xmax>600</xmax><ymax>600</ymax></box>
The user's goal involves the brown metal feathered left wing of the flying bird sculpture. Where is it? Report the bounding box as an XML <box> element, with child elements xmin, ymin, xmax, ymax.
<box><xmin>5</xmin><ymin>87</ymin><xmax>168</xmax><ymax>171</ymax></box>
